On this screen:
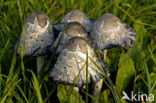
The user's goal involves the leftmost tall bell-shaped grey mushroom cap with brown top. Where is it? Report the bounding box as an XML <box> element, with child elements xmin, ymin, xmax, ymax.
<box><xmin>19</xmin><ymin>11</ymin><xmax>54</xmax><ymax>56</ymax></box>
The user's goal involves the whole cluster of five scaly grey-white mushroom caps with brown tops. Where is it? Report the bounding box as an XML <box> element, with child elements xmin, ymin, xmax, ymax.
<box><xmin>16</xmin><ymin>10</ymin><xmax>136</xmax><ymax>98</ymax></box>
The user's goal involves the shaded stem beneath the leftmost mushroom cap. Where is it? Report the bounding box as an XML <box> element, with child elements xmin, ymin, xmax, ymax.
<box><xmin>37</xmin><ymin>56</ymin><xmax>45</xmax><ymax>78</ymax></box>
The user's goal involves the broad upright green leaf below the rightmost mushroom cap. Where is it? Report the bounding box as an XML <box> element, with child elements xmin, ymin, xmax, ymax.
<box><xmin>116</xmin><ymin>54</ymin><xmax>136</xmax><ymax>94</ymax></box>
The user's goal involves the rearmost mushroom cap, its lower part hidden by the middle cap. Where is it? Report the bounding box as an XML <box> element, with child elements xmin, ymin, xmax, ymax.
<box><xmin>55</xmin><ymin>9</ymin><xmax>93</xmax><ymax>32</ymax></box>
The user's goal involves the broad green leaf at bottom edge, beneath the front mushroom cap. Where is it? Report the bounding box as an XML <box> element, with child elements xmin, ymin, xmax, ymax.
<box><xmin>57</xmin><ymin>84</ymin><xmax>84</xmax><ymax>103</ymax></box>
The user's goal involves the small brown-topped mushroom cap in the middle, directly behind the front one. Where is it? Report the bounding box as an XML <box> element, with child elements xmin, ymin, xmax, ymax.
<box><xmin>49</xmin><ymin>22</ymin><xmax>89</xmax><ymax>54</ymax></box>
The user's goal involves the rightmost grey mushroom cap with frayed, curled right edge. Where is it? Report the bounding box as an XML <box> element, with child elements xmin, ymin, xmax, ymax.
<box><xmin>90</xmin><ymin>14</ymin><xmax>136</xmax><ymax>50</ymax></box>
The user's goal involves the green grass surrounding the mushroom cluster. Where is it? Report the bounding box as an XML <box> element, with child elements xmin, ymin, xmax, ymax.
<box><xmin>0</xmin><ymin>0</ymin><xmax>156</xmax><ymax>103</ymax></box>
